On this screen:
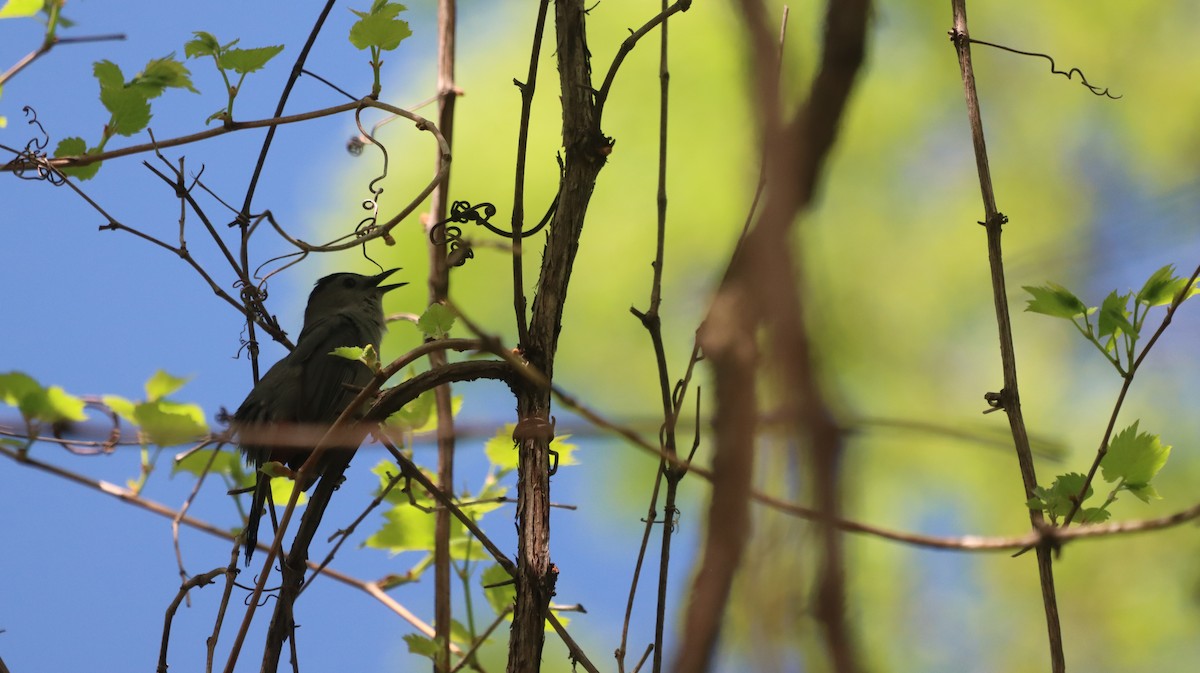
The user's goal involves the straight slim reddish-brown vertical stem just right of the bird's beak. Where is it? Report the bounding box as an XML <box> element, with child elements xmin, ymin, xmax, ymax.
<box><xmin>430</xmin><ymin>0</ymin><xmax>457</xmax><ymax>672</ymax></box>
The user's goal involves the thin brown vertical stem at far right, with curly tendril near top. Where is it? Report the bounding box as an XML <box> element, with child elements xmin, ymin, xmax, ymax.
<box><xmin>950</xmin><ymin>0</ymin><xmax>1067</xmax><ymax>673</ymax></box>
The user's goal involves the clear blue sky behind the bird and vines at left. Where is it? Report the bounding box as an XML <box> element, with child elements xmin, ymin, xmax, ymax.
<box><xmin>0</xmin><ymin>1</ymin><xmax>694</xmax><ymax>671</ymax></box>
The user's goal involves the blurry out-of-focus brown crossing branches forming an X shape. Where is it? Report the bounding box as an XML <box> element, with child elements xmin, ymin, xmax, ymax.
<box><xmin>676</xmin><ymin>0</ymin><xmax>869</xmax><ymax>672</ymax></box>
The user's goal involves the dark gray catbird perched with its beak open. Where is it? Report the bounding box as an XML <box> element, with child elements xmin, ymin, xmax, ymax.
<box><xmin>233</xmin><ymin>269</ymin><xmax>407</xmax><ymax>564</ymax></box>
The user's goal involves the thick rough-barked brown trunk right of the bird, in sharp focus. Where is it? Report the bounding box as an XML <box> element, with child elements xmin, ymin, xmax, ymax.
<box><xmin>508</xmin><ymin>0</ymin><xmax>611</xmax><ymax>673</ymax></box>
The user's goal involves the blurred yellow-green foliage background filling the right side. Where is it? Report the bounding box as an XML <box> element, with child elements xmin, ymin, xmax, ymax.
<box><xmin>304</xmin><ymin>0</ymin><xmax>1200</xmax><ymax>672</ymax></box>
